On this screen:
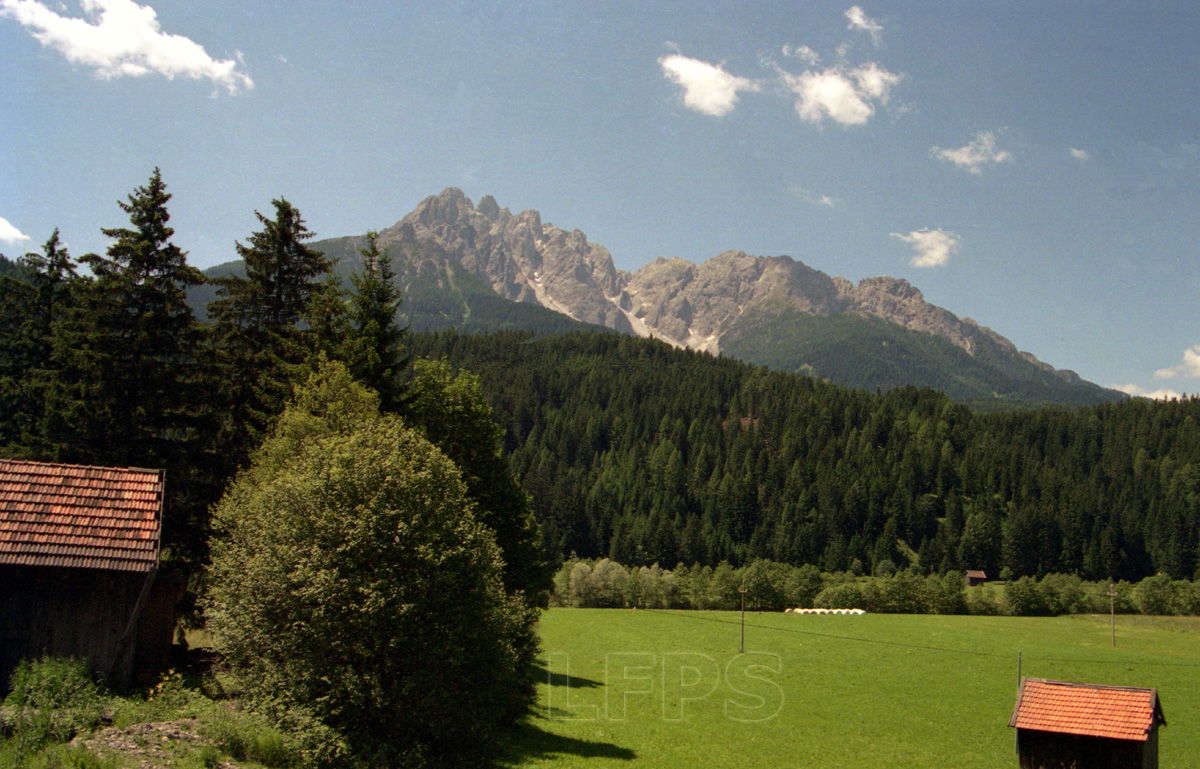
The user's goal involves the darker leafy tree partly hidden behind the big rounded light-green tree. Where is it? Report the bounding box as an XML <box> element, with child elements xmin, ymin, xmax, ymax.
<box><xmin>403</xmin><ymin>360</ymin><xmax>553</xmax><ymax>606</ymax></box>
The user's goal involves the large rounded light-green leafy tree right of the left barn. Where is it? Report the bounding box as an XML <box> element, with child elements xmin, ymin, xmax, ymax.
<box><xmin>208</xmin><ymin>364</ymin><xmax>536</xmax><ymax>767</ymax></box>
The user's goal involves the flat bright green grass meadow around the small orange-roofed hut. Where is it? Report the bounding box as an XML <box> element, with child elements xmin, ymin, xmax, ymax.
<box><xmin>494</xmin><ymin>608</ymin><xmax>1200</xmax><ymax>769</ymax></box>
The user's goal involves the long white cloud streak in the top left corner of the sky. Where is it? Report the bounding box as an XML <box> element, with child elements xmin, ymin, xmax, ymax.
<box><xmin>0</xmin><ymin>0</ymin><xmax>254</xmax><ymax>94</ymax></box>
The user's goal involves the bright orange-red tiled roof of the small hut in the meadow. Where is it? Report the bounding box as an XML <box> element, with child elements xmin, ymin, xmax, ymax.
<box><xmin>1008</xmin><ymin>678</ymin><xmax>1166</xmax><ymax>741</ymax></box>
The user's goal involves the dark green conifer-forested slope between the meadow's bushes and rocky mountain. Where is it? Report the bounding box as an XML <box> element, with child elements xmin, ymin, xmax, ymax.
<box><xmin>412</xmin><ymin>332</ymin><xmax>1200</xmax><ymax>578</ymax></box>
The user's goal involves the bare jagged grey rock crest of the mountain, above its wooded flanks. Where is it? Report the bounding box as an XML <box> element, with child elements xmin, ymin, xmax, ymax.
<box><xmin>382</xmin><ymin>187</ymin><xmax>1099</xmax><ymax>388</ymax></box>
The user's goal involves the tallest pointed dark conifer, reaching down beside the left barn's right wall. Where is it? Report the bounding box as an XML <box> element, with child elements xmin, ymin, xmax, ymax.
<box><xmin>47</xmin><ymin>168</ymin><xmax>214</xmax><ymax>560</ymax></box>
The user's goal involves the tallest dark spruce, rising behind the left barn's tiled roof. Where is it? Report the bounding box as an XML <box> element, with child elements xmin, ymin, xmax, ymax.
<box><xmin>55</xmin><ymin>168</ymin><xmax>204</xmax><ymax>467</ymax></box>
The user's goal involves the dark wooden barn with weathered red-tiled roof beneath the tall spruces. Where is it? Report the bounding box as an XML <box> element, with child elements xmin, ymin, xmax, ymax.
<box><xmin>0</xmin><ymin>459</ymin><xmax>182</xmax><ymax>691</ymax></box>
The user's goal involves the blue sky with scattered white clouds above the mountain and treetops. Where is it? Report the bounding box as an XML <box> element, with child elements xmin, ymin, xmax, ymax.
<box><xmin>0</xmin><ymin>0</ymin><xmax>1200</xmax><ymax>395</ymax></box>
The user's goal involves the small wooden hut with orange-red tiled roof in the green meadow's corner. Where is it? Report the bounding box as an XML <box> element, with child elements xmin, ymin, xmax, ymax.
<box><xmin>1008</xmin><ymin>678</ymin><xmax>1166</xmax><ymax>769</ymax></box>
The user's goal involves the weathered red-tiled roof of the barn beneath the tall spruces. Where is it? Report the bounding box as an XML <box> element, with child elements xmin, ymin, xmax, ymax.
<box><xmin>0</xmin><ymin>459</ymin><xmax>163</xmax><ymax>571</ymax></box>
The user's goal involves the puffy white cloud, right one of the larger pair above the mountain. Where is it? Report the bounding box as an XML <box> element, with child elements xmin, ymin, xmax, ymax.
<box><xmin>780</xmin><ymin>64</ymin><xmax>902</xmax><ymax>126</ymax></box>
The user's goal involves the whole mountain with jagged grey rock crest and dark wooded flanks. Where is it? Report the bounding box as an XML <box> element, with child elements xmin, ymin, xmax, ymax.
<box><xmin>199</xmin><ymin>187</ymin><xmax>1124</xmax><ymax>407</ymax></box>
